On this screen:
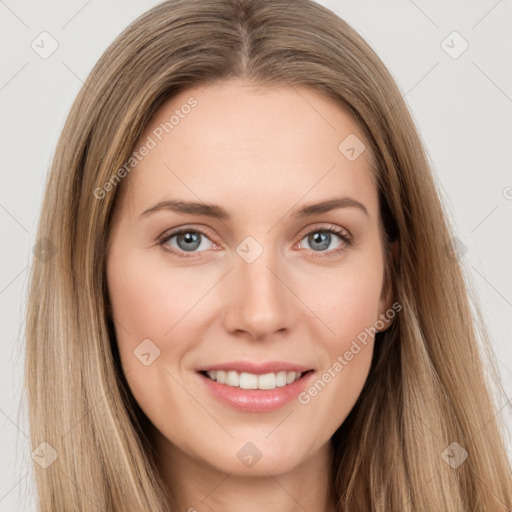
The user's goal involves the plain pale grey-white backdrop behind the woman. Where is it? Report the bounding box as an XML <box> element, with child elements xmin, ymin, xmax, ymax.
<box><xmin>0</xmin><ymin>0</ymin><xmax>512</xmax><ymax>511</ymax></box>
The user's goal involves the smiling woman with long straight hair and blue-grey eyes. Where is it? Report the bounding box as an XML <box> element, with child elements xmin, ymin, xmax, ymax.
<box><xmin>26</xmin><ymin>0</ymin><xmax>512</xmax><ymax>512</ymax></box>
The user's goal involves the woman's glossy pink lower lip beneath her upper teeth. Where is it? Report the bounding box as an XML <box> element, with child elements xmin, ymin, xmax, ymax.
<box><xmin>198</xmin><ymin>371</ymin><xmax>314</xmax><ymax>412</ymax></box>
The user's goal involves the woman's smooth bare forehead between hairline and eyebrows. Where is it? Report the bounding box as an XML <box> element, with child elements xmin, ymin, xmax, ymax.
<box><xmin>118</xmin><ymin>80</ymin><xmax>377</xmax><ymax>222</ymax></box>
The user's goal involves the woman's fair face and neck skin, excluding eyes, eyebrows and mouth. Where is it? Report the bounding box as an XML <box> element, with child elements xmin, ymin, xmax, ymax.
<box><xmin>107</xmin><ymin>79</ymin><xmax>392</xmax><ymax>512</ymax></box>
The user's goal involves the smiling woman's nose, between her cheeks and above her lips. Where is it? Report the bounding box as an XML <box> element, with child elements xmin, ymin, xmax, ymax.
<box><xmin>224</xmin><ymin>250</ymin><xmax>301</xmax><ymax>340</ymax></box>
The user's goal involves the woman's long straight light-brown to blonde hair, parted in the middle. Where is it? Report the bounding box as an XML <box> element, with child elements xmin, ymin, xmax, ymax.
<box><xmin>25</xmin><ymin>0</ymin><xmax>512</xmax><ymax>512</ymax></box>
